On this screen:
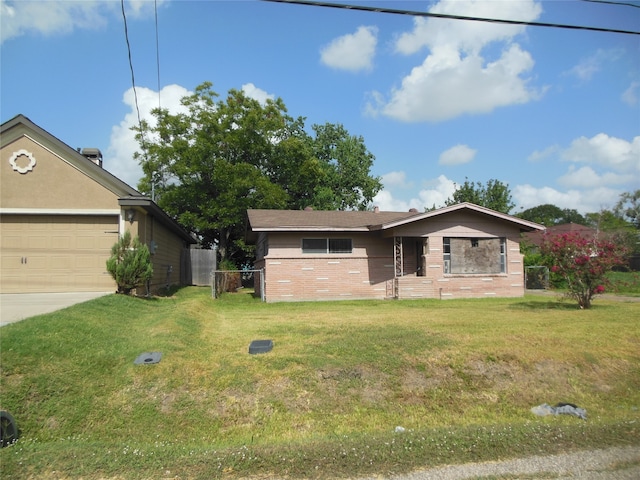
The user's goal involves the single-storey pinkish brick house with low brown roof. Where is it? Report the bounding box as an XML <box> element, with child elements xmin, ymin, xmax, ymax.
<box><xmin>248</xmin><ymin>203</ymin><xmax>544</xmax><ymax>302</ymax></box>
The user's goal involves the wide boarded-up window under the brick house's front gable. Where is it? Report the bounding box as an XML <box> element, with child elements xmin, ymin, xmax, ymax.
<box><xmin>442</xmin><ymin>237</ymin><xmax>507</xmax><ymax>275</ymax></box>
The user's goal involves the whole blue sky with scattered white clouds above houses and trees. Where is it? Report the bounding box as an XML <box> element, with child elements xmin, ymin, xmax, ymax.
<box><xmin>0</xmin><ymin>0</ymin><xmax>640</xmax><ymax>213</ymax></box>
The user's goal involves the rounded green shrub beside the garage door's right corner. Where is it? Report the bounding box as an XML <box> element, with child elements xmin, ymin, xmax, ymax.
<box><xmin>107</xmin><ymin>230</ymin><xmax>153</xmax><ymax>295</ymax></box>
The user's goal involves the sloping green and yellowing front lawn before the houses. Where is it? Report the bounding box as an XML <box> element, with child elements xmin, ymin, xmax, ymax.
<box><xmin>0</xmin><ymin>287</ymin><xmax>640</xmax><ymax>479</ymax></box>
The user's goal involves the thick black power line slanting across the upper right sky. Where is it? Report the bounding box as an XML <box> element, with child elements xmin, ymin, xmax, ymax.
<box><xmin>262</xmin><ymin>0</ymin><xmax>640</xmax><ymax>35</ymax></box>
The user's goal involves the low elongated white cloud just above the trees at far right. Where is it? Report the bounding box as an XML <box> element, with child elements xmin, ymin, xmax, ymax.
<box><xmin>511</xmin><ymin>184</ymin><xmax>621</xmax><ymax>214</ymax></box>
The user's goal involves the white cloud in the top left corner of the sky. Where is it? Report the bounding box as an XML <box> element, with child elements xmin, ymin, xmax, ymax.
<box><xmin>0</xmin><ymin>0</ymin><xmax>163</xmax><ymax>43</ymax></box>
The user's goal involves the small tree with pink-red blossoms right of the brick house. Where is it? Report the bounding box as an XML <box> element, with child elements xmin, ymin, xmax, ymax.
<box><xmin>541</xmin><ymin>232</ymin><xmax>626</xmax><ymax>308</ymax></box>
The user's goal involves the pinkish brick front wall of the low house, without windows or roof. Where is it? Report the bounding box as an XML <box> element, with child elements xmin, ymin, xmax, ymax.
<box><xmin>255</xmin><ymin>225</ymin><xmax>524</xmax><ymax>302</ymax></box>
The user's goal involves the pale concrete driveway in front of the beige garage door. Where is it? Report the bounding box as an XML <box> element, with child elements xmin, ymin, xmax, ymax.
<box><xmin>0</xmin><ymin>291</ymin><xmax>113</xmax><ymax>327</ymax></box>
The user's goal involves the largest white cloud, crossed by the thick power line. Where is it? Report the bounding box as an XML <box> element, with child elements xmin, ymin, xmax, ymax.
<box><xmin>367</xmin><ymin>0</ymin><xmax>543</xmax><ymax>122</ymax></box>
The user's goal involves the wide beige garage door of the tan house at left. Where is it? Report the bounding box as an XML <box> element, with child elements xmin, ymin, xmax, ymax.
<box><xmin>0</xmin><ymin>215</ymin><xmax>118</xmax><ymax>293</ymax></box>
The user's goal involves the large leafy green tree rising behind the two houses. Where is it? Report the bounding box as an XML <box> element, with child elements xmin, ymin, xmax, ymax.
<box><xmin>136</xmin><ymin>82</ymin><xmax>382</xmax><ymax>265</ymax></box>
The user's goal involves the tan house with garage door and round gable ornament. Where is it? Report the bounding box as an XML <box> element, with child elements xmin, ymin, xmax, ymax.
<box><xmin>0</xmin><ymin>115</ymin><xmax>195</xmax><ymax>293</ymax></box>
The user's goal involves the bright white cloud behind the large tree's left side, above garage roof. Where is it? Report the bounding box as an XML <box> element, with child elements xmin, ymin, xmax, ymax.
<box><xmin>104</xmin><ymin>85</ymin><xmax>191</xmax><ymax>188</ymax></box>
